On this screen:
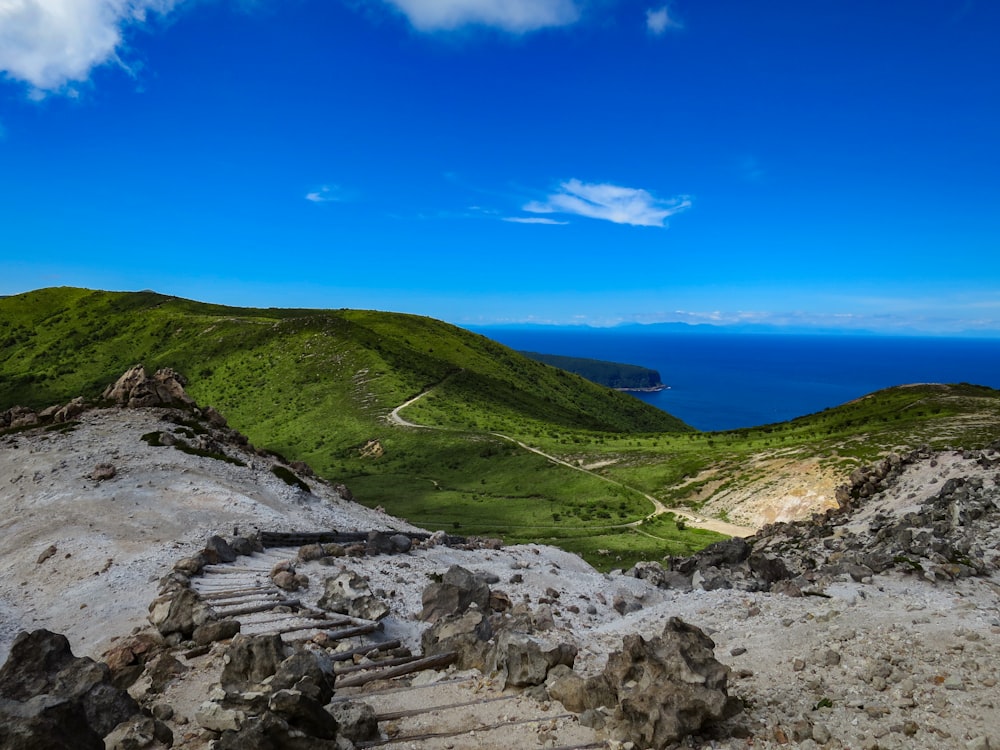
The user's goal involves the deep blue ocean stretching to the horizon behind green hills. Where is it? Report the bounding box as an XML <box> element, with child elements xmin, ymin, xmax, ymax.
<box><xmin>475</xmin><ymin>327</ymin><xmax>1000</xmax><ymax>431</ymax></box>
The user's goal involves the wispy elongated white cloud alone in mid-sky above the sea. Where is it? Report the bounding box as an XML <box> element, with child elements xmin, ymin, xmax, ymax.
<box><xmin>524</xmin><ymin>180</ymin><xmax>691</xmax><ymax>227</ymax></box>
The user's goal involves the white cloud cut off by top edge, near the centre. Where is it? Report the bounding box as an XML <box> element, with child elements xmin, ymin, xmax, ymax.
<box><xmin>385</xmin><ymin>0</ymin><xmax>580</xmax><ymax>33</ymax></box>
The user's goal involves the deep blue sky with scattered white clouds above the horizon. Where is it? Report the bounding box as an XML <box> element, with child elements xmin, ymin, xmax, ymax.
<box><xmin>0</xmin><ymin>0</ymin><xmax>1000</xmax><ymax>333</ymax></box>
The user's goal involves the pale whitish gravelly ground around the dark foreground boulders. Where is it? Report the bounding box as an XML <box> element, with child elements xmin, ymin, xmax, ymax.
<box><xmin>0</xmin><ymin>409</ymin><xmax>1000</xmax><ymax>750</ymax></box>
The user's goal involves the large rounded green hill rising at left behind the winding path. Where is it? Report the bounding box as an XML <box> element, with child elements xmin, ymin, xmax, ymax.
<box><xmin>0</xmin><ymin>288</ymin><xmax>690</xmax><ymax>434</ymax></box>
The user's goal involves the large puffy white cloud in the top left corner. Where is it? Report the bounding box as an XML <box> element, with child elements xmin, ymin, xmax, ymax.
<box><xmin>0</xmin><ymin>0</ymin><xmax>183</xmax><ymax>98</ymax></box>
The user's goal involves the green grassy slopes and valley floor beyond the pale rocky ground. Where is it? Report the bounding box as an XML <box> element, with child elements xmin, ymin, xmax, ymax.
<box><xmin>7</xmin><ymin>289</ymin><xmax>1000</xmax><ymax>567</ymax></box>
